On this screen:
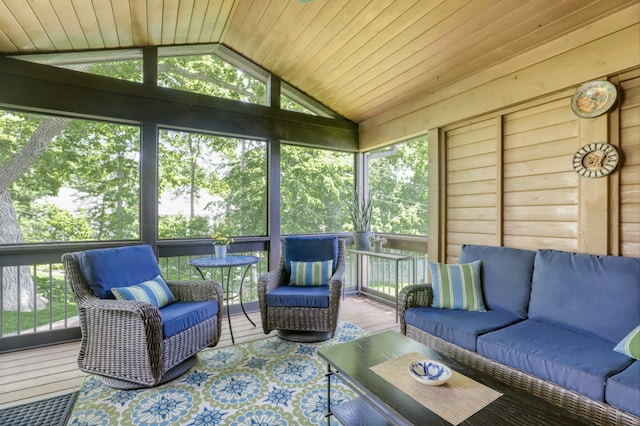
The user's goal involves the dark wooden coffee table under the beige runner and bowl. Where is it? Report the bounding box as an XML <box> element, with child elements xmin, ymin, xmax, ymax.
<box><xmin>318</xmin><ymin>331</ymin><xmax>591</xmax><ymax>426</ymax></box>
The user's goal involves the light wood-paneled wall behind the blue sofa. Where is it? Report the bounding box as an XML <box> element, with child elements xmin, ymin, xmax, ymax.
<box><xmin>436</xmin><ymin>69</ymin><xmax>640</xmax><ymax>262</ymax></box>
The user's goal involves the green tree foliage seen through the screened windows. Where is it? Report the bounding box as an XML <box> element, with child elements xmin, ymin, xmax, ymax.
<box><xmin>0</xmin><ymin>55</ymin><xmax>427</xmax><ymax>243</ymax></box>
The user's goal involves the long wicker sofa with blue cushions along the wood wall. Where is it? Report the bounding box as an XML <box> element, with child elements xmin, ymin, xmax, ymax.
<box><xmin>400</xmin><ymin>245</ymin><xmax>640</xmax><ymax>425</ymax></box>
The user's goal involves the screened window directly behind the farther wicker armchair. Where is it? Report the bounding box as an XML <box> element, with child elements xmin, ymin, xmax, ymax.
<box><xmin>280</xmin><ymin>145</ymin><xmax>354</xmax><ymax>234</ymax></box>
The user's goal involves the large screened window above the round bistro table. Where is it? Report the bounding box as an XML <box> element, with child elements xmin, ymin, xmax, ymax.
<box><xmin>158</xmin><ymin>129</ymin><xmax>267</xmax><ymax>239</ymax></box>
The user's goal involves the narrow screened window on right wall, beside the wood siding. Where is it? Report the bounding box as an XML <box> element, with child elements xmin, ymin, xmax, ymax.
<box><xmin>367</xmin><ymin>137</ymin><xmax>429</xmax><ymax>235</ymax></box>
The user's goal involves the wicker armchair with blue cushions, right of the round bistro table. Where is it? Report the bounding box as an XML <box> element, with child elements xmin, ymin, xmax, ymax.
<box><xmin>258</xmin><ymin>237</ymin><xmax>346</xmax><ymax>342</ymax></box>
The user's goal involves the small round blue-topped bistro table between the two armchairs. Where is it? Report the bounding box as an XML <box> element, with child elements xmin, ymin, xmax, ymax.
<box><xmin>189</xmin><ymin>256</ymin><xmax>260</xmax><ymax>344</ymax></box>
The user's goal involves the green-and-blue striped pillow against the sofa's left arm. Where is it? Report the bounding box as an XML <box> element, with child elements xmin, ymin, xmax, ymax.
<box><xmin>429</xmin><ymin>260</ymin><xmax>486</xmax><ymax>312</ymax></box>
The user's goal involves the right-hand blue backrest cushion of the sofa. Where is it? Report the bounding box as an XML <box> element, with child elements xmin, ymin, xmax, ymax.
<box><xmin>529</xmin><ymin>250</ymin><xmax>640</xmax><ymax>344</ymax></box>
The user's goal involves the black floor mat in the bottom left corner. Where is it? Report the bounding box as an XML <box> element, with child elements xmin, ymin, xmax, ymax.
<box><xmin>0</xmin><ymin>392</ymin><xmax>78</xmax><ymax>426</ymax></box>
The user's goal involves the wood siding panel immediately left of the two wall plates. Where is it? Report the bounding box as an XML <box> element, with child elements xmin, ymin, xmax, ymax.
<box><xmin>502</xmin><ymin>99</ymin><xmax>580</xmax><ymax>251</ymax></box>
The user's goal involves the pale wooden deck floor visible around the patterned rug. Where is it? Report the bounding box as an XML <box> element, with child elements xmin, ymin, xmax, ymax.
<box><xmin>0</xmin><ymin>296</ymin><xmax>399</xmax><ymax>409</ymax></box>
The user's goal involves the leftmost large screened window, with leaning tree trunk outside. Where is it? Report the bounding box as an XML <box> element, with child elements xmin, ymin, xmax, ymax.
<box><xmin>0</xmin><ymin>110</ymin><xmax>140</xmax><ymax>244</ymax></box>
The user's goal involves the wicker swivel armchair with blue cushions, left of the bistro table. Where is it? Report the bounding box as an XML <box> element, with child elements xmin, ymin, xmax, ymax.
<box><xmin>62</xmin><ymin>245</ymin><xmax>222</xmax><ymax>389</ymax></box>
